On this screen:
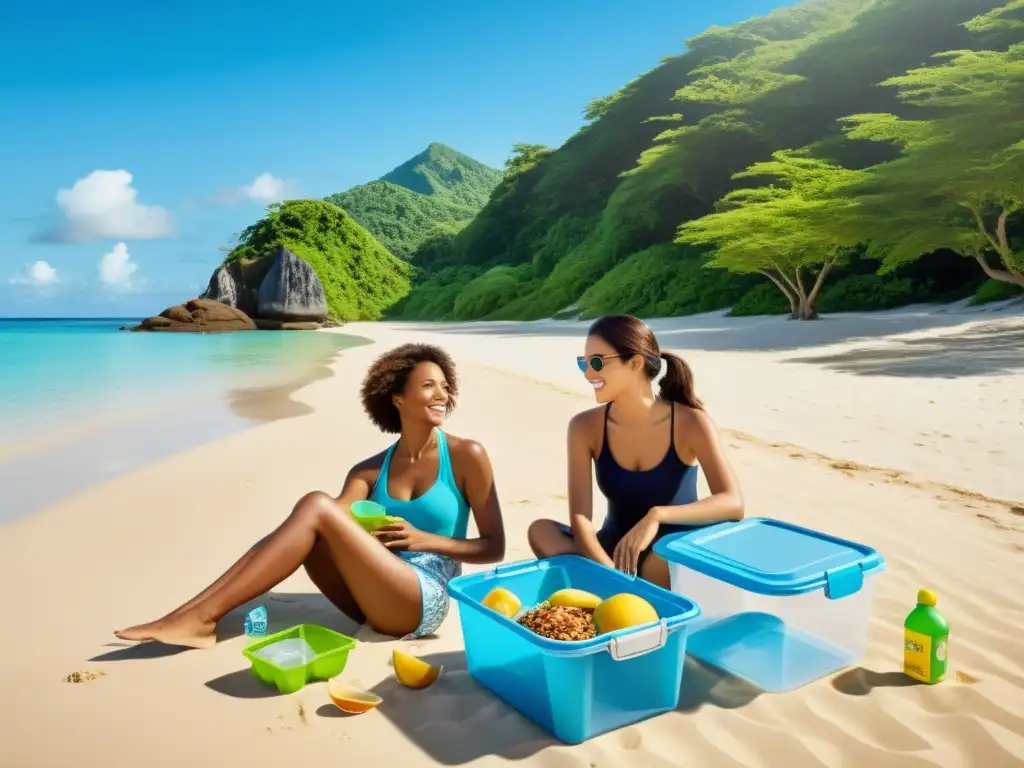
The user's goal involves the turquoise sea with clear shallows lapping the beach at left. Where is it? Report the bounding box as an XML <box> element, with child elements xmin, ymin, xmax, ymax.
<box><xmin>0</xmin><ymin>318</ymin><xmax>367</xmax><ymax>521</ymax></box>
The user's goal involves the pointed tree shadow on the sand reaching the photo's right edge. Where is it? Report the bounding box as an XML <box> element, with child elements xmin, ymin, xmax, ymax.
<box><xmin>785</xmin><ymin>328</ymin><xmax>1024</xmax><ymax>379</ymax></box>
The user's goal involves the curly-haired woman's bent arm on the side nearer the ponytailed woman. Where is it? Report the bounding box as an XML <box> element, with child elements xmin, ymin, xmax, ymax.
<box><xmin>417</xmin><ymin>440</ymin><xmax>505</xmax><ymax>563</ymax></box>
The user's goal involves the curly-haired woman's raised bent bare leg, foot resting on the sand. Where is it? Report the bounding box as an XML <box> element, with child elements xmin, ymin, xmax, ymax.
<box><xmin>117</xmin><ymin>492</ymin><xmax>421</xmax><ymax>647</ymax></box>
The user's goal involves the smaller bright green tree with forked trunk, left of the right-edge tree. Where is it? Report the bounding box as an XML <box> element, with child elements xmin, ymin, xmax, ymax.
<box><xmin>677</xmin><ymin>150</ymin><xmax>860</xmax><ymax>319</ymax></box>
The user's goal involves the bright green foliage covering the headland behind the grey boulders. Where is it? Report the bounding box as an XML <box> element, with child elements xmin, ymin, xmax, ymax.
<box><xmin>226</xmin><ymin>200</ymin><xmax>410</xmax><ymax>321</ymax></box>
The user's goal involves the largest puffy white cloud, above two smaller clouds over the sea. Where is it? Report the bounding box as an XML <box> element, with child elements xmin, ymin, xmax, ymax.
<box><xmin>45</xmin><ymin>170</ymin><xmax>174</xmax><ymax>243</ymax></box>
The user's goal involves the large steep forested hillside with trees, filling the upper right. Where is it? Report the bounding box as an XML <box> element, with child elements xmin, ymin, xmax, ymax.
<box><xmin>389</xmin><ymin>0</ymin><xmax>1024</xmax><ymax>319</ymax></box>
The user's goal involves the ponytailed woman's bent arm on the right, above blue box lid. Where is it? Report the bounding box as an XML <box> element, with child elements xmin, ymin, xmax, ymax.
<box><xmin>648</xmin><ymin>410</ymin><xmax>743</xmax><ymax>525</ymax></box>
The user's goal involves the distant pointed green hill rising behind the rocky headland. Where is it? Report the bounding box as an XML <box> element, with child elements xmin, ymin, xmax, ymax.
<box><xmin>327</xmin><ymin>143</ymin><xmax>502</xmax><ymax>258</ymax></box>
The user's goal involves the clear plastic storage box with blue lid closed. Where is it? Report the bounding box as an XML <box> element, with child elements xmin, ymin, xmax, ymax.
<box><xmin>654</xmin><ymin>517</ymin><xmax>885</xmax><ymax>692</ymax></box>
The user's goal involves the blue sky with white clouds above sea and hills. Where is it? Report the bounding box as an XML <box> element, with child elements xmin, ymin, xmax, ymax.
<box><xmin>0</xmin><ymin>0</ymin><xmax>790</xmax><ymax>317</ymax></box>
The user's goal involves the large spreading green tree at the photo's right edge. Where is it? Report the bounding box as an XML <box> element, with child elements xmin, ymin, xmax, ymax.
<box><xmin>842</xmin><ymin>35</ymin><xmax>1024</xmax><ymax>286</ymax></box>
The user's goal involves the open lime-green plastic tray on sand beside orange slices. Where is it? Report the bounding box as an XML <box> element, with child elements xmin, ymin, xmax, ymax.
<box><xmin>242</xmin><ymin>624</ymin><xmax>355</xmax><ymax>693</ymax></box>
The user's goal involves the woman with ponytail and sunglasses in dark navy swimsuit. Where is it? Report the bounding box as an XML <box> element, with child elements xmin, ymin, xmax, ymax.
<box><xmin>529</xmin><ymin>314</ymin><xmax>743</xmax><ymax>588</ymax></box>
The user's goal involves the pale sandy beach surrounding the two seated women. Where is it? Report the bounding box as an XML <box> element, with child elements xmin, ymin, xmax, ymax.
<box><xmin>0</xmin><ymin>308</ymin><xmax>1024</xmax><ymax>768</ymax></box>
